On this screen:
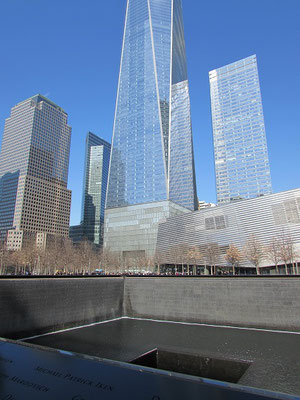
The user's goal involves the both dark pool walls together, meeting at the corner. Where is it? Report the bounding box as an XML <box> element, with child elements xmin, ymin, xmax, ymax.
<box><xmin>0</xmin><ymin>277</ymin><xmax>300</xmax><ymax>338</ymax></box>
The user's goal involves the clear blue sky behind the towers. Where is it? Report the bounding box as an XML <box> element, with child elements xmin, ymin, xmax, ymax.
<box><xmin>0</xmin><ymin>0</ymin><xmax>300</xmax><ymax>224</ymax></box>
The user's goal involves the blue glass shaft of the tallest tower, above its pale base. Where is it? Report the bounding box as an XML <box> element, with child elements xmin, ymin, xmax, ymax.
<box><xmin>106</xmin><ymin>0</ymin><xmax>197</xmax><ymax>210</ymax></box>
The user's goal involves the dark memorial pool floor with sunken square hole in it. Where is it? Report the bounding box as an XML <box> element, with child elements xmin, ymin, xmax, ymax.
<box><xmin>25</xmin><ymin>318</ymin><xmax>300</xmax><ymax>395</ymax></box>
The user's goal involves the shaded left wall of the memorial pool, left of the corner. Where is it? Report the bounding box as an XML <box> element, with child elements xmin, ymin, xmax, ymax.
<box><xmin>0</xmin><ymin>278</ymin><xmax>124</xmax><ymax>338</ymax></box>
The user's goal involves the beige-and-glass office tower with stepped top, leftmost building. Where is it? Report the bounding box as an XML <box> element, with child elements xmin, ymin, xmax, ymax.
<box><xmin>0</xmin><ymin>95</ymin><xmax>71</xmax><ymax>249</ymax></box>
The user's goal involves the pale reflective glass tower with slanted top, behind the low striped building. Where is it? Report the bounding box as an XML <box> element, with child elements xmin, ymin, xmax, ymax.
<box><xmin>209</xmin><ymin>55</ymin><xmax>272</xmax><ymax>204</ymax></box>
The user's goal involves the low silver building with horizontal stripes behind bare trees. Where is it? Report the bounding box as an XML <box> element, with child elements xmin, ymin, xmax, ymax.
<box><xmin>157</xmin><ymin>189</ymin><xmax>300</xmax><ymax>268</ymax></box>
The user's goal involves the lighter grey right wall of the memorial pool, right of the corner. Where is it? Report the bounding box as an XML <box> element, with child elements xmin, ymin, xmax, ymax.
<box><xmin>123</xmin><ymin>277</ymin><xmax>300</xmax><ymax>331</ymax></box>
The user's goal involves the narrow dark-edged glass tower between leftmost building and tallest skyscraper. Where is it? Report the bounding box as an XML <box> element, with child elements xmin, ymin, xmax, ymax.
<box><xmin>81</xmin><ymin>132</ymin><xmax>111</xmax><ymax>245</ymax></box>
